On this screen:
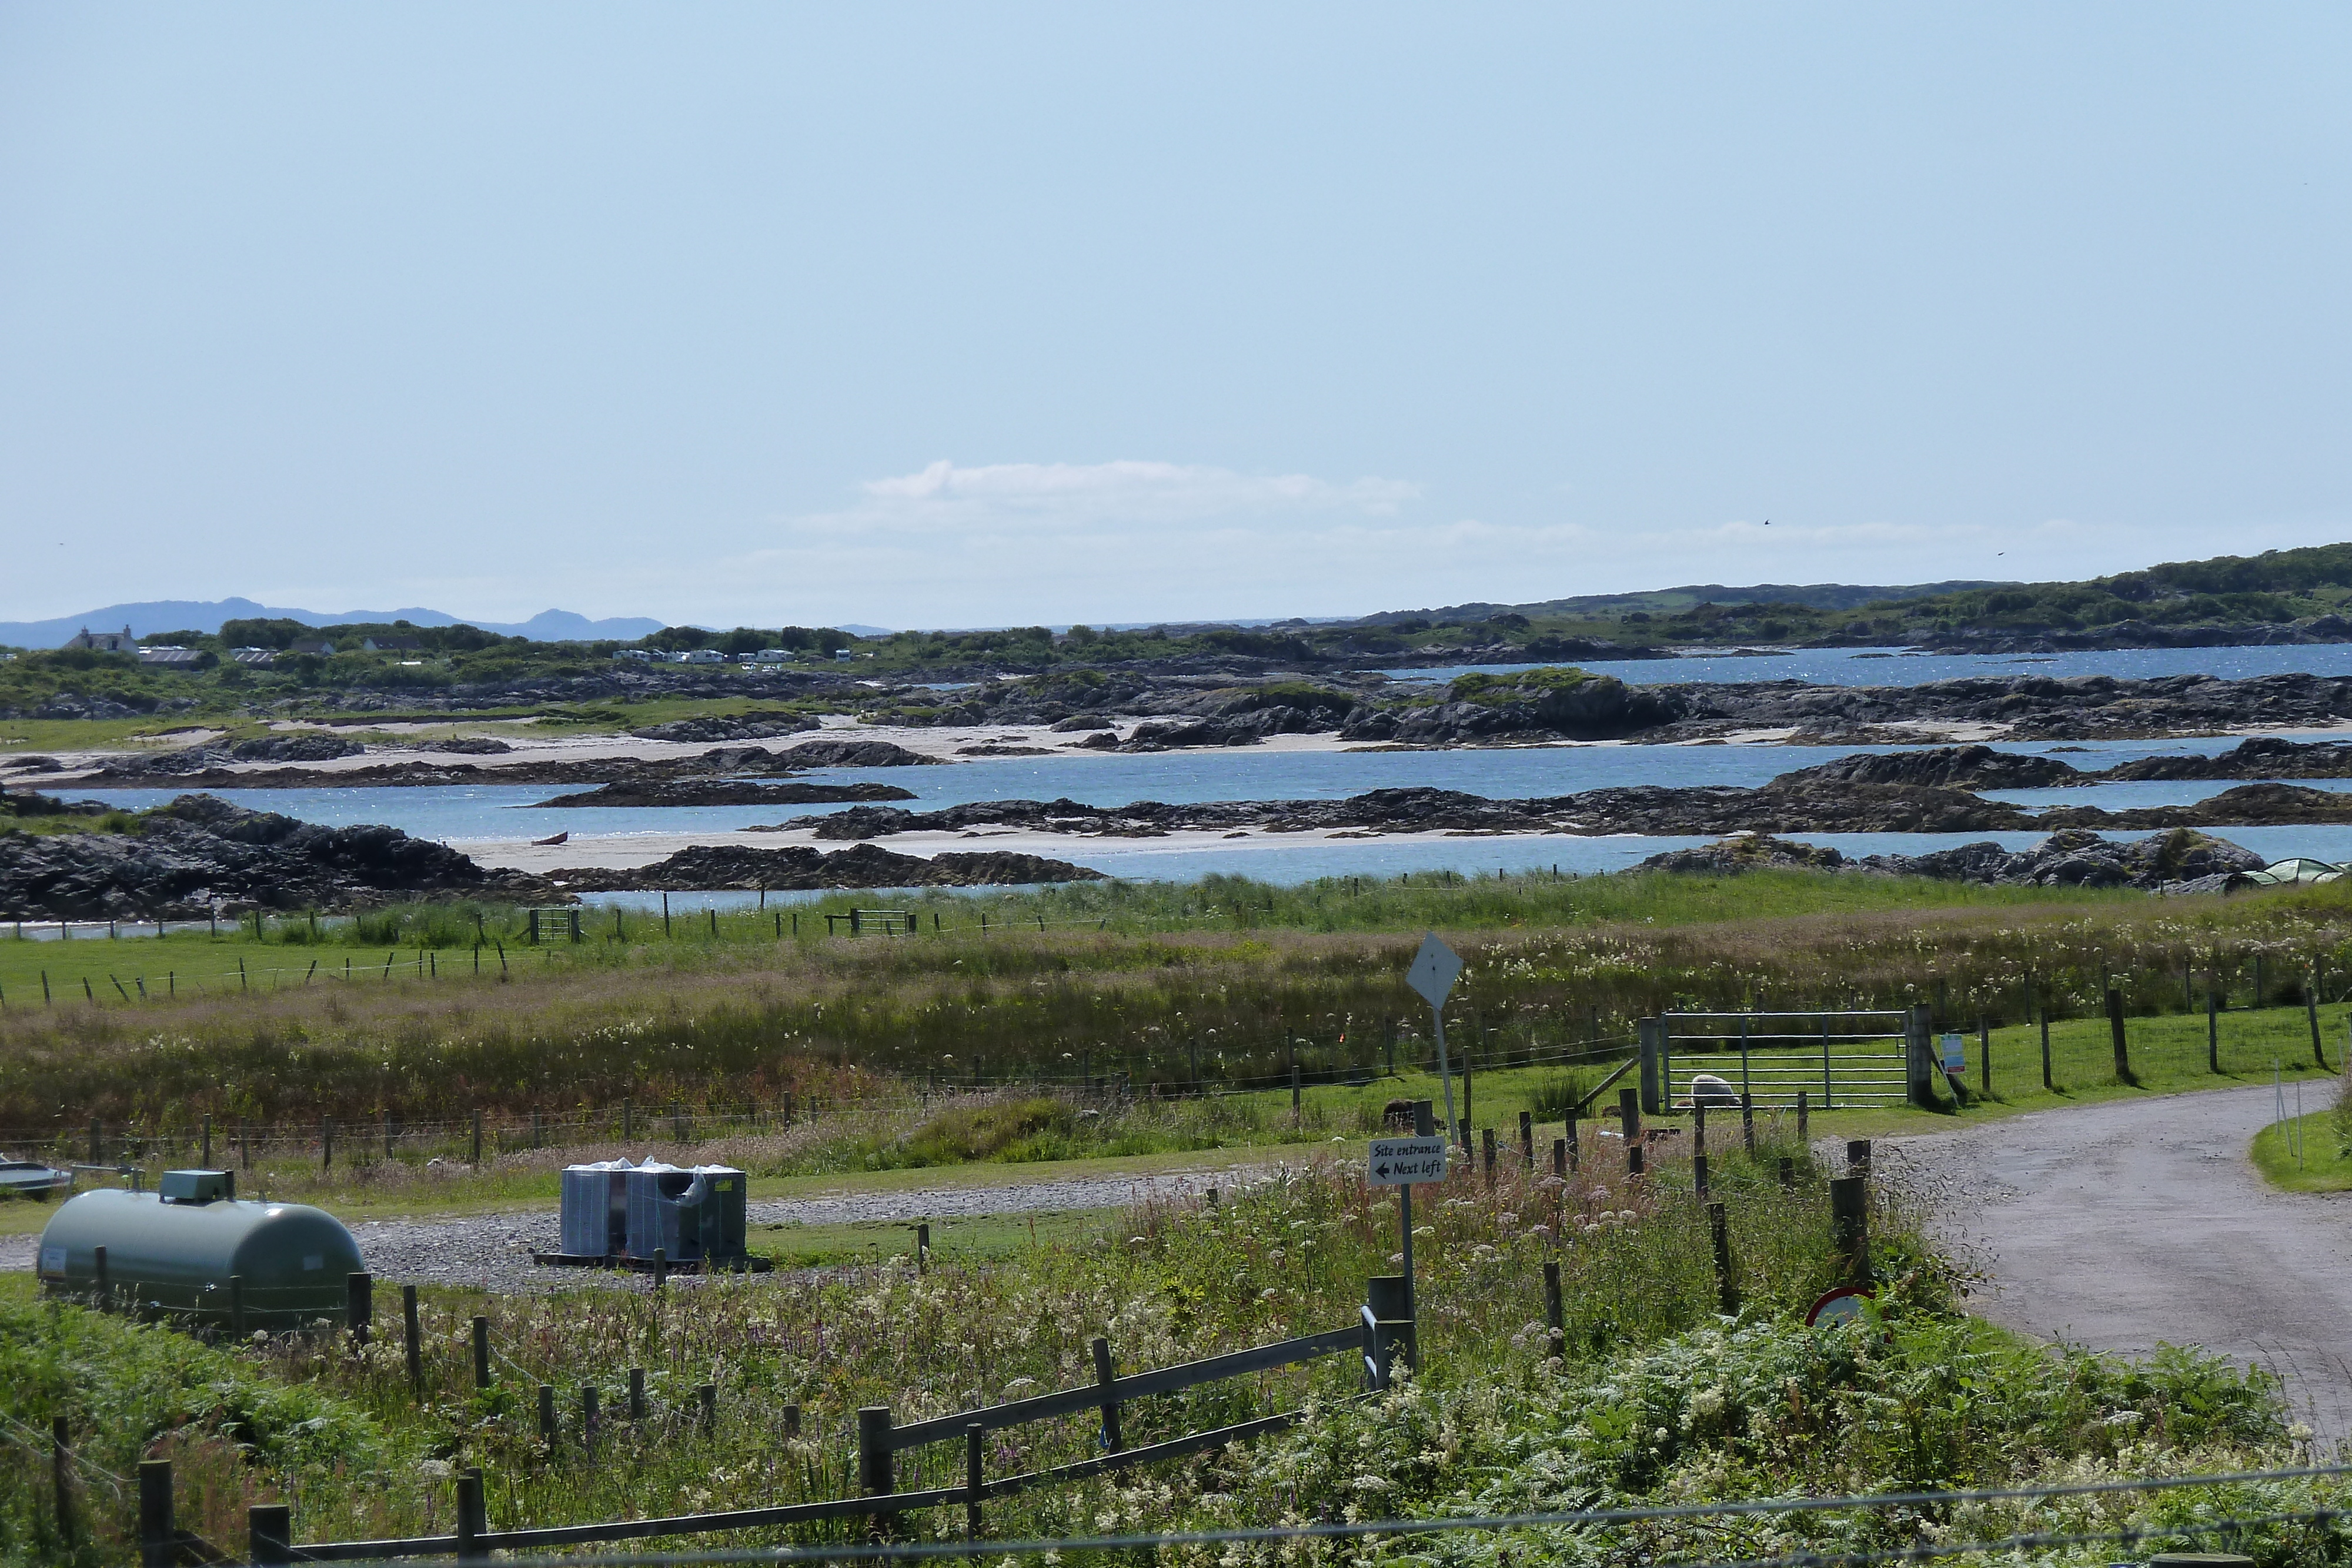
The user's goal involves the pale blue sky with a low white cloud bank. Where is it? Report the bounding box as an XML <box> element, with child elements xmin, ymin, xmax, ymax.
<box><xmin>0</xmin><ymin>0</ymin><xmax>2352</xmax><ymax>626</ymax></box>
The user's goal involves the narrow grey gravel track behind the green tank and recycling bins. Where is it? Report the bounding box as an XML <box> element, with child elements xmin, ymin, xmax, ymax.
<box><xmin>0</xmin><ymin>1166</ymin><xmax>1261</xmax><ymax>1290</ymax></box>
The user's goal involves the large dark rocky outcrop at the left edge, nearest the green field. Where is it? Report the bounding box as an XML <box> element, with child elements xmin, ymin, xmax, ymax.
<box><xmin>0</xmin><ymin>794</ymin><xmax>555</xmax><ymax>919</ymax></box>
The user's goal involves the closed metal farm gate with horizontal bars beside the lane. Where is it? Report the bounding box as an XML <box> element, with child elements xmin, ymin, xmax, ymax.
<box><xmin>1642</xmin><ymin>1011</ymin><xmax>1917</xmax><ymax>1114</ymax></box>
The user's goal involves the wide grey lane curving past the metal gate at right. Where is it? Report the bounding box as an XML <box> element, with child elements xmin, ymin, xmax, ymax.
<box><xmin>1889</xmin><ymin>1084</ymin><xmax>2352</xmax><ymax>1436</ymax></box>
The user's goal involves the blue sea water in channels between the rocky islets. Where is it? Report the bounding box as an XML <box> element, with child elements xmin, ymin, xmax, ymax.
<box><xmin>51</xmin><ymin>644</ymin><xmax>2352</xmax><ymax>884</ymax></box>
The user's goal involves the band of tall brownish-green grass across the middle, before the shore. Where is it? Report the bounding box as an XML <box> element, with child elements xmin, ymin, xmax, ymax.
<box><xmin>0</xmin><ymin>872</ymin><xmax>2352</xmax><ymax>1128</ymax></box>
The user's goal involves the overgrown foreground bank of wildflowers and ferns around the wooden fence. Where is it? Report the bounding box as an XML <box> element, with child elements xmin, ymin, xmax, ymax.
<box><xmin>0</xmin><ymin>1149</ymin><xmax>2340</xmax><ymax>1568</ymax></box>
